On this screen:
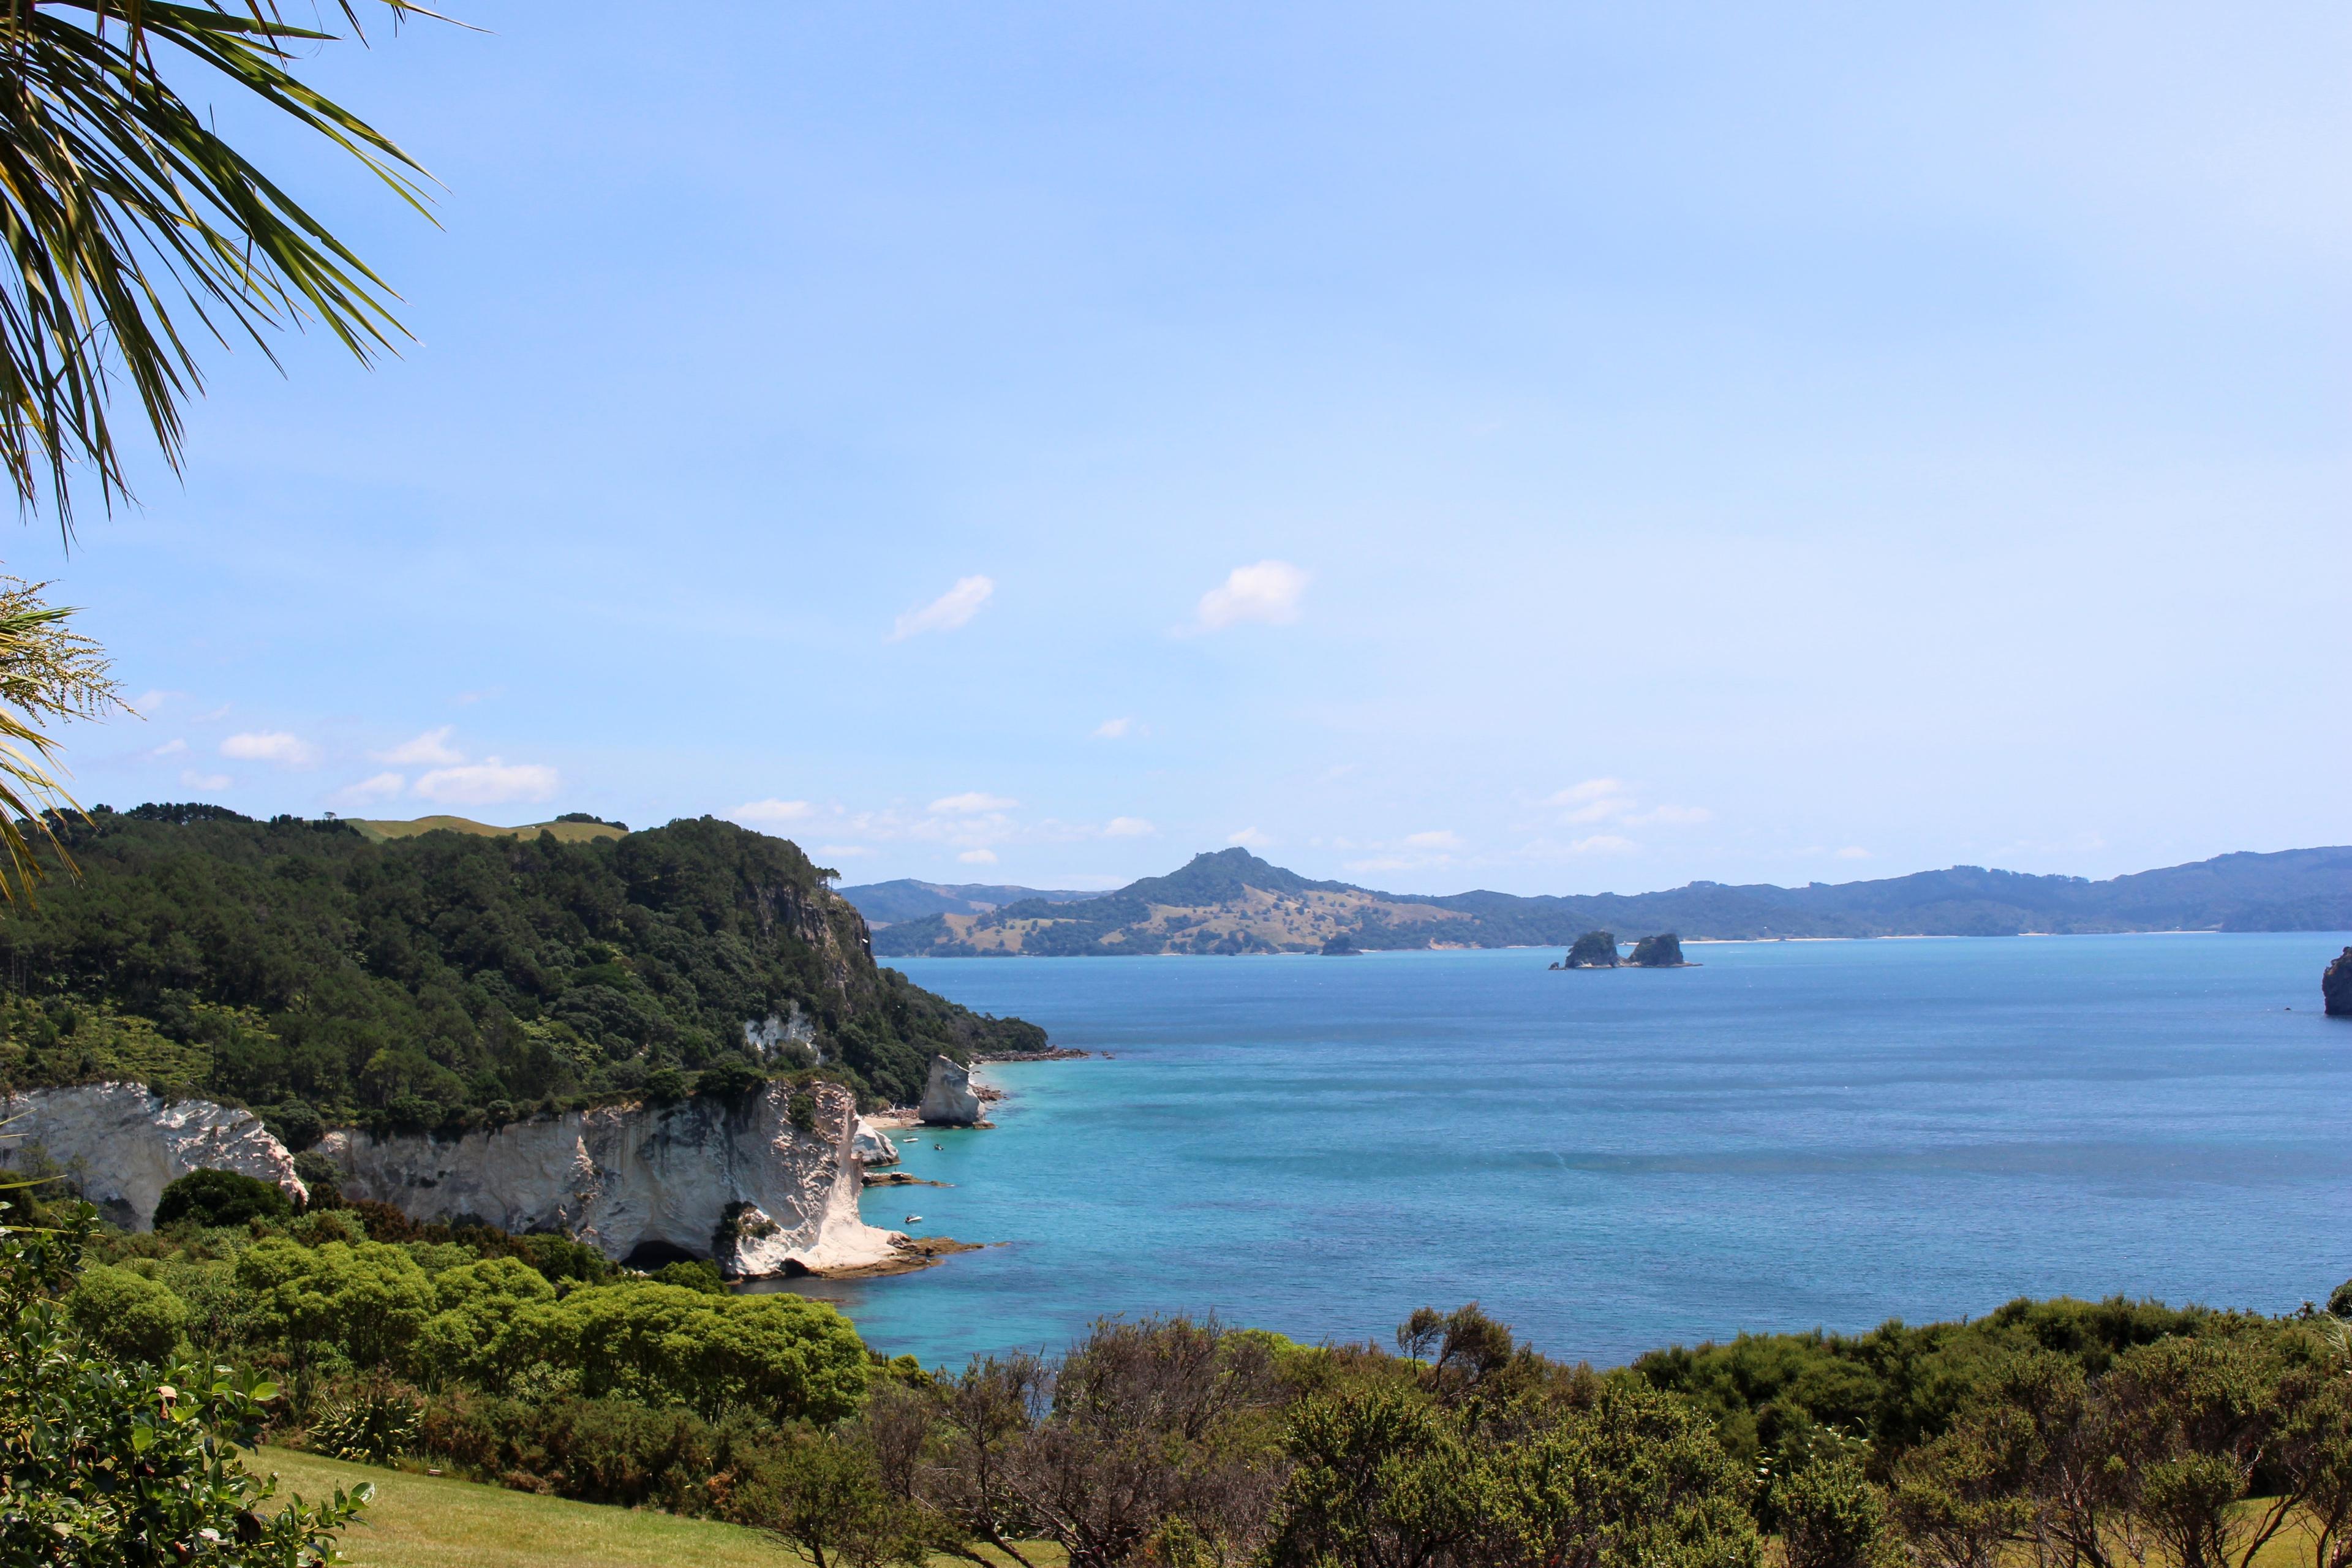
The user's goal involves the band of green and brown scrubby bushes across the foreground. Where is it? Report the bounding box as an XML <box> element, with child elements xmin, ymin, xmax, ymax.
<box><xmin>13</xmin><ymin>1170</ymin><xmax>2352</xmax><ymax>1568</ymax></box>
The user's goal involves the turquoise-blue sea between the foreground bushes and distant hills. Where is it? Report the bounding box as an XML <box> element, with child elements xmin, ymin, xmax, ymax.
<box><xmin>795</xmin><ymin>933</ymin><xmax>2352</xmax><ymax>1363</ymax></box>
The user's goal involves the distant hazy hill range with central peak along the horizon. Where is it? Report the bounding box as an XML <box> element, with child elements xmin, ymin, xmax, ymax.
<box><xmin>875</xmin><ymin>849</ymin><xmax>2352</xmax><ymax>957</ymax></box>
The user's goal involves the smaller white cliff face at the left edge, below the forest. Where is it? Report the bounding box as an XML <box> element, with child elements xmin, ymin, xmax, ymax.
<box><xmin>0</xmin><ymin>1084</ymin><xmax>308</xmax><ymax>1229</ymax></box>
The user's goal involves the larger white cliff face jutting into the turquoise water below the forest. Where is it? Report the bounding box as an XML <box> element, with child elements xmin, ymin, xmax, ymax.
<box><xmin>320</xmin><ymin>1084</ymin><xmax>896</xmax><ymax>1279</ymax></box>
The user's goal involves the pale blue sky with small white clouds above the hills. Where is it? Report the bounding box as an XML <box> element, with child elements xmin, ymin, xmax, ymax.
<box><xmin>23</xmin><ymin>0</ymin><xmax>2352</xmax><ymax>891</ymax></box>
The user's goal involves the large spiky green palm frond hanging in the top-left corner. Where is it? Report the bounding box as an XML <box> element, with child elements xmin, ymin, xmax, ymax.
<box><xmin>0</xmin><ymin>0</ymin><xmax>431</xmax><ymax>531</ymax></box>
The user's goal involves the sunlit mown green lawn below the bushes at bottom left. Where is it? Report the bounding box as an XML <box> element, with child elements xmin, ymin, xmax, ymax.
<box><xmin>249</xmin><ymin>1448</ymin><xmax>804</xmax><ymax>1568</ymax></box>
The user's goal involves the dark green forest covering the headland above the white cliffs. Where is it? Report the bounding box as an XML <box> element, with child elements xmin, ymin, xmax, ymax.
<box><xmin>0</xmin><ymin>806</ymin><xmax>1044</xmax><ymax>1142</ymax></box>
